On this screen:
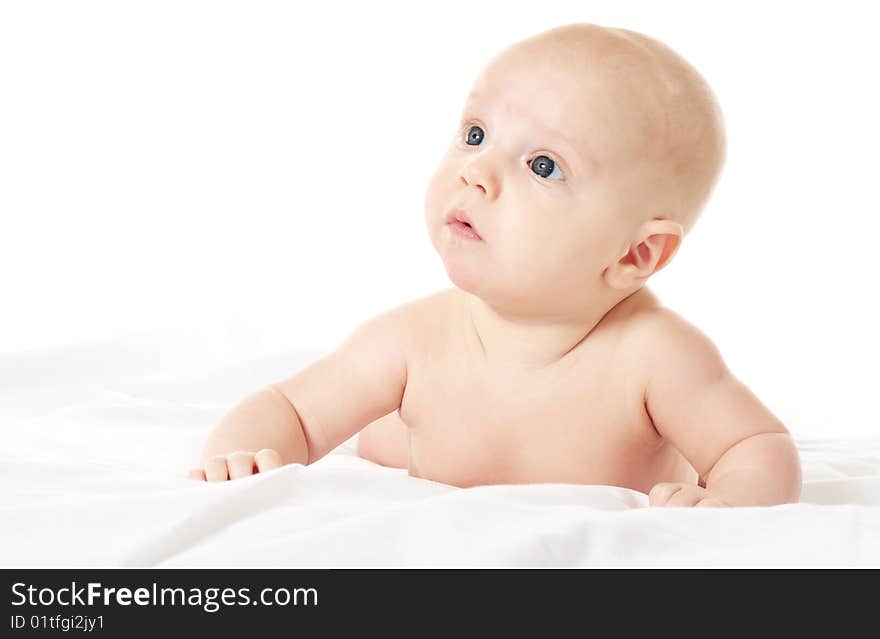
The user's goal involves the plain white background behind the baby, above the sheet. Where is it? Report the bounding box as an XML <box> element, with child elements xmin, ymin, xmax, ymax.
<box><xmin>0</xmin><ymin>0</ymin><xmax>880</xmax><ymax>436</ymax></box>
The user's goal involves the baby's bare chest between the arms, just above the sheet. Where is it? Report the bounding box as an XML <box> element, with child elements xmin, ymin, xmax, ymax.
<box><xmin>400</xmin><ymin>344</ymin><xmax>658</xmax><ymax>487</ymax></box>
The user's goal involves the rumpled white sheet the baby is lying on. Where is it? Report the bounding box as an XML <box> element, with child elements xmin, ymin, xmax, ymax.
<box><xmin>0</xmin><ymin>332</ymin><xmax>880</xmax><ymax>567</ymax></box>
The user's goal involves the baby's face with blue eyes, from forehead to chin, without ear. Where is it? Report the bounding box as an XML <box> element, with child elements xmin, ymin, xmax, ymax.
<box><xmin>425</xmin><ymin>33</ymin><xmax>688</xmax><ymax>312</ymax></box>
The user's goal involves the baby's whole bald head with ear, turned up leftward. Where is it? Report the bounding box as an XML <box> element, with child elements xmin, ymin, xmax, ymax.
<box><xmin>425</xmin><ymin>24</ymin><xmax>725</xmax><ymax>315</ymax></box>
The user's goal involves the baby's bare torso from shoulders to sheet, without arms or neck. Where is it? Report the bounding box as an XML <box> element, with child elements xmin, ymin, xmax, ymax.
<box><xmin>358</xmin><ymin>288</ymin><xmax>697</xmax><ymax>493</ymax></box>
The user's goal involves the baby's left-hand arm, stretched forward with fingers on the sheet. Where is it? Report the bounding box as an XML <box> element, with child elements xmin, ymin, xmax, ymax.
<box><xmin>190</xmin><ymin>307</ymin><xmax>406</xmax><ymax>481</ymax></box>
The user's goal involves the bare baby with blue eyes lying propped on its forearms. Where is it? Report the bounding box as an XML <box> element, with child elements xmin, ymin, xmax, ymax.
<box><xmin>190</xmin><ymin>24</ymin><xmax>801</xmax><ymax>506</ymax></box>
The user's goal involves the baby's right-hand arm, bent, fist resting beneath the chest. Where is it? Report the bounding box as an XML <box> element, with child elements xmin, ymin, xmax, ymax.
<box><xmin>645</xmin><ymin>314</ymin><xmax>801</xmax><ymax>506</ymax></box>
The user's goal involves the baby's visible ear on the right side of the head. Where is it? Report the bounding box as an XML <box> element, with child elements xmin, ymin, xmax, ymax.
<box><xmin>603</xmin><ymin>219</ymin><xmax>684</xmax><ymax>289</ymax></box>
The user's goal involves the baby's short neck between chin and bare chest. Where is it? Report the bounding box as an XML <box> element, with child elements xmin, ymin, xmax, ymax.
<box><xmin>459</xmin><ymin>289</ymin><xmax>642</xmax><ymax>370</ymax></box>
